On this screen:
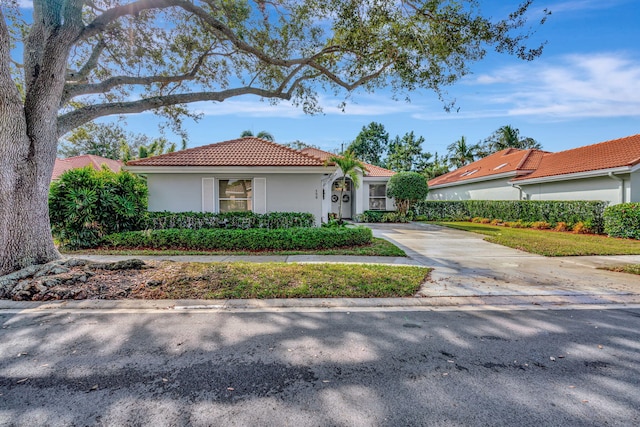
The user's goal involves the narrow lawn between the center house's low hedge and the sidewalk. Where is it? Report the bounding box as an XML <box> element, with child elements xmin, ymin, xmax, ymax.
<box><xmin>62</xmin><ymin>237</ymin><xmax>407</xmax><ymax>257</ymax></box>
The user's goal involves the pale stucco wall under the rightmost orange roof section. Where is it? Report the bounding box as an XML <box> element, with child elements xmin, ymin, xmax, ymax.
<box><xmin>521</xmin><ymin>174</ymin><xmax>631</xmax><ymax>204</ymax></box>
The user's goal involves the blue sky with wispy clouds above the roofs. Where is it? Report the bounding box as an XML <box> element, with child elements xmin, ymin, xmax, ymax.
<box><xmin>18</xmin><ymin>0</ymin><xmax>640</xmax><ymax>154</ymax></box>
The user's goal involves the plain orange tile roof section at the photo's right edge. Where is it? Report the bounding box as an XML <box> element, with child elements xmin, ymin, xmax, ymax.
<box><xmin>516</xmin><ymin>134</ymin><xmax>640</xmax><ymax>180</ymax></box>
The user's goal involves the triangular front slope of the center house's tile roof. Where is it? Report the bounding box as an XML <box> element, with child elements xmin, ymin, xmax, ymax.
<box><xmin>127</xmin><ymin>137</ymin><xmax>324</xmax><ymax>166</ymax></box>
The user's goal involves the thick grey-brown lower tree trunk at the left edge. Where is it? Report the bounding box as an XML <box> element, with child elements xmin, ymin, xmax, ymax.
<box><xmin>0</xmin><ymin>92</ymin><xmax>60</xmax><ymax>275</ymax></box>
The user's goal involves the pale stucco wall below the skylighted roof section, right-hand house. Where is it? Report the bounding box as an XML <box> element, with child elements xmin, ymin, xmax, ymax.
<box><xmin>427</xmin><ymin>178</ymin><xmax>520</xmax><ymax>200</ymax></box>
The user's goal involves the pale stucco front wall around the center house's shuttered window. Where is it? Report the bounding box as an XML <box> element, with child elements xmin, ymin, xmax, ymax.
<box><xmin>146</xmin><ymin>173</ymin><xmax>323</xmax><ymax>225</ymax></box>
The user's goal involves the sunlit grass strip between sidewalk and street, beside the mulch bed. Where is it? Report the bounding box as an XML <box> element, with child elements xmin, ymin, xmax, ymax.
<box><xmin>131</xmin><ymin>262</ymin><xmax>431</xmax><ymax>299</ymax></box>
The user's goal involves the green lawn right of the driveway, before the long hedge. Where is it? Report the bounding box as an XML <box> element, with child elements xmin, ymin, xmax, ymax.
<box><xmin>436</xmin><ymin>222</ymin><xmax>640</xmax><ymax>256</ymax></box>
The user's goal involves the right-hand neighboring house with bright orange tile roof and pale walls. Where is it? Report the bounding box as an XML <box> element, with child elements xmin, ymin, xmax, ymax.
<box><xmin>428</xmin><ymin>135</ymin><xmax>640</xmax><ymax>204</ymax></box>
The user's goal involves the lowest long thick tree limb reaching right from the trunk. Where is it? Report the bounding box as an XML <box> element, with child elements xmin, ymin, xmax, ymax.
<box><xmin>58</xmin><ymin>86</ymin><xmax>295</xmax><ymax>137</ymax></box>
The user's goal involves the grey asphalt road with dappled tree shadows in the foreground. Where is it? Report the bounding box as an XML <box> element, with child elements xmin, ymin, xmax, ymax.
<box><xmin>0</xmin><ymin>308</ymin><xmax>640</xmax><ymax>426</ymax></box>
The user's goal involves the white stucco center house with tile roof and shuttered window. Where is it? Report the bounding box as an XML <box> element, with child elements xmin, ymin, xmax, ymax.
<box><xmin>125</xmin><ymin>137</ymin><xmax>394</xmax><ymax>225</ymax></box>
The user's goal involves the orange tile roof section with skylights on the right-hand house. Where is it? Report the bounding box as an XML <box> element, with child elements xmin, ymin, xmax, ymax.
<box><xmin>429</xmin><ymin>148</ymin><xmax>548</xmax><ymax>187</ymax></box>
